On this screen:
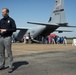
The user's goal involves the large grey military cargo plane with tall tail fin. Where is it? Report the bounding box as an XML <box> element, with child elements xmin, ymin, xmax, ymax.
<box><xmin>16</xmin><ymin>0</ymin><xmax>76</xmax><ymax>41</ymax></box>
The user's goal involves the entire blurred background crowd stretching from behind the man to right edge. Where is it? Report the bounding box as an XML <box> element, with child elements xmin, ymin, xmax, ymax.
<box><xmin>12</xmin><ymin>33</ymin><xmax>76</xmax><ymax>46</ymax></box>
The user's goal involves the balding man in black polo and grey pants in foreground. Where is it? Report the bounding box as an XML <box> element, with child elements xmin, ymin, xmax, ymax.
<box><xmin>0</xmin><ymin>8</ymin><xmax>16</xmax><ymax>73</ymax></box>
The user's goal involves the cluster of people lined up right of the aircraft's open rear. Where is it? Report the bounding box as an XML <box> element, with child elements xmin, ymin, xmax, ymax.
<box><xmin>42</xmin><ymin>36</ymin><xmax>67</xmax><ymax>45</ymax></box>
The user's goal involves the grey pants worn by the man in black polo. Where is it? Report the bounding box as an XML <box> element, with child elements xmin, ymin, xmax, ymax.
<box><xmin>0</xmin><ymin>37</ymin><xmax>13</xmax><ymax>68</ymax></box>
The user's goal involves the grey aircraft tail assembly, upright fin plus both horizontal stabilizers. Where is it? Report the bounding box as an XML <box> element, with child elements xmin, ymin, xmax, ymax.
<box><xmin>27</xmin><ymin>0</ymin><xmax>76</xmax><ymax>28</ymax></box>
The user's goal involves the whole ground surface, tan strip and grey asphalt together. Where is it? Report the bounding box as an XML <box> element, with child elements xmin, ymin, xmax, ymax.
<box><xmin>0</xmin><ymin>43</ymin><xmax>76</xmax><ymax>75</ymax></box>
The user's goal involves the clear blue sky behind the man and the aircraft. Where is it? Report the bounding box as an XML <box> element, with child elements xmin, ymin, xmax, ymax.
<box><xmin>0</xmin><ymin>0</ymin><xmax>76</xmax><ymax>37</ymax></box>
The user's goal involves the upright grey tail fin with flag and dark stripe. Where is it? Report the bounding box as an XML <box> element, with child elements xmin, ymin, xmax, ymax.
<box><xmin>48</xmin><ymin>0</ymin><xmax>66</xmax><ymax>24</ymax></box>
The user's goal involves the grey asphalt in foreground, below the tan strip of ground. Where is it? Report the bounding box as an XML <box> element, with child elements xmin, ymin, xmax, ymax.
<box><xmin>0</xmin><ymin>50</ymin><xmax>76</xmax><ymax>75</ymax></box>
